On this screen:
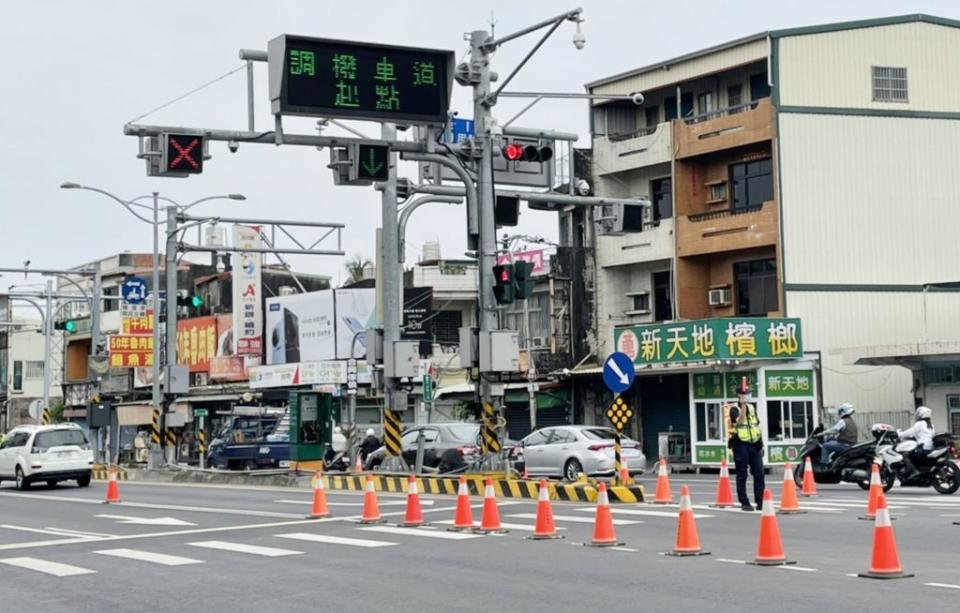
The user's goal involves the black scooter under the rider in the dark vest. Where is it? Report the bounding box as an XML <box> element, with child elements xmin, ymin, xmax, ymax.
<box><xmin>795</xmin><ymin>424</ymin><xmax>896</xmax><ymax>492</ymax></box>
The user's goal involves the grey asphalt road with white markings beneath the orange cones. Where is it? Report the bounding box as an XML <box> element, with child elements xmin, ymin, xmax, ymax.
<box><xmin>0</xmin><ymin>475</ymin><xmax>960</xmax><ymax>613</ymax></box>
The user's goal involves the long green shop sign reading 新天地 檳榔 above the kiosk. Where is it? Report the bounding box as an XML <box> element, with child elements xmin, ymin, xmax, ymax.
<box><xmin>613</xmin><ymin>318</ymin><xmax>803</xmax><ymax>364</ymax></box>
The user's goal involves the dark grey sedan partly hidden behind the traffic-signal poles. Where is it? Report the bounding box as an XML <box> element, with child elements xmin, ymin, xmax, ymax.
<box><xmin>364</xmin><ymin>422</ymin><xmax>488</xmax><ymax>473</ymax></box>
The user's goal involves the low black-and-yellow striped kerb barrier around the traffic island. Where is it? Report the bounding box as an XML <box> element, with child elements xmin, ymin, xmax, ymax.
<box><xmin>324</xmin><ymin>473</ymin><xmax>644</xmax><ymax>503</ymax></box>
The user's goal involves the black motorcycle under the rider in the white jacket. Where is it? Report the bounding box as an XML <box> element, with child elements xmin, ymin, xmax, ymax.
<box><xmin>877</xmin><ymin>428</ymin><xmax>960</xmax><ymax>494</ymax></box>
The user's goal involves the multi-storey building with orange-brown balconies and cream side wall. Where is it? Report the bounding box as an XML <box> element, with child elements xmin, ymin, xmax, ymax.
<box><xmin>586</xmin><ymin>15</ymin><xmax>960</xmax><ymax>461</ymax></box>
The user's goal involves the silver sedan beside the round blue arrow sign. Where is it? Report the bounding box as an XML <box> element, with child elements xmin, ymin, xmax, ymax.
<box><xmin>511</xmin><ymin>426</ymin><xmax>647</xmax><ymax>481</ymax></box>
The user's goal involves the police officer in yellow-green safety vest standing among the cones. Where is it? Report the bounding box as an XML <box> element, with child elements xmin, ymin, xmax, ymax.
<box><xmin>728</xmin><ymin>377</ymin><xmax>764</xmax><ymax>511</ymax></box>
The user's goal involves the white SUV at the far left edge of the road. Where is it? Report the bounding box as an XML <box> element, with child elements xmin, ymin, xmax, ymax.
<box><xmin>0</xmin><ymin>424</ymin><xmax>93</xmax><ymax>490</ymax></box>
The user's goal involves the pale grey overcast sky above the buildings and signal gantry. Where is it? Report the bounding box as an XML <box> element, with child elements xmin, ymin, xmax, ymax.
<box><xmin>0</xmin><ymin>0</ymin><xmax>960</xmax><ymax>291</ymax></box>
